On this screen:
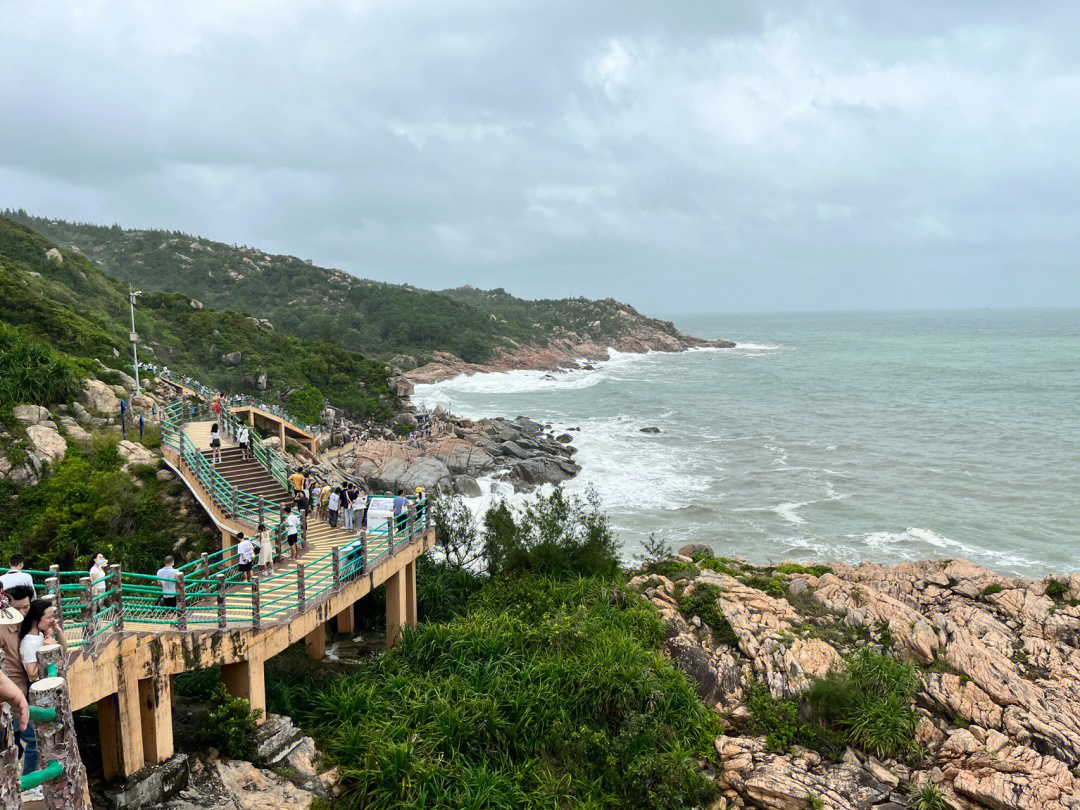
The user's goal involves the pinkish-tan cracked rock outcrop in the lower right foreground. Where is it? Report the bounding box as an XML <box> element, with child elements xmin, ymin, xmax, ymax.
<box><xmin>631</xmin><ymin>545</ymin><xmax>1080</xmax><ymax>810</ymax></box>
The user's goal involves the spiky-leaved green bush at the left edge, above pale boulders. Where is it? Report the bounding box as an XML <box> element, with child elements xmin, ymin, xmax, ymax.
<box><xmin>0</xmin><ymin>322</ymin><xmax>85</xmax><ymax>405</ymax></box>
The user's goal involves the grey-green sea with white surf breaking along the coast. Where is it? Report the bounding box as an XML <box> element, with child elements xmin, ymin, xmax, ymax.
<box><xmin>416</xmin><ymin>310</ymin><xmax>1080</xmax><ymax>576</ymax></box>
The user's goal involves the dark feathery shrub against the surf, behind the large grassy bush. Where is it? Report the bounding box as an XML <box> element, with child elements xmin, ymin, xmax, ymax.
<box><xmin>484</xmin><ymin>487</ymin><xmax>620</xmax><ymax>577</ymax></box>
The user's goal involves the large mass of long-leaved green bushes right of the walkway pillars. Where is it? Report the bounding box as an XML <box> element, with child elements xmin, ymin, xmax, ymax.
<box><xmin>274</xmin><ymin>571</ymin><xmax>719</xmax><ymax>810</ymax></box>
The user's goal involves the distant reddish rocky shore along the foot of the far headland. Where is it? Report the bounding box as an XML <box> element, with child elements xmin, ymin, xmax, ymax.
<box><xmin>405</xmin><ymin>326</ymin><xmax>734</xmax><ymax>384</ymax></box>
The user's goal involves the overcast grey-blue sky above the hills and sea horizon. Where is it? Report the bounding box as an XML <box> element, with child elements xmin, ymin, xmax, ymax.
<box><xmin>0</xmin><ymin>0</ymin><xmax>1080</xmax><ymax>312</ymax></box>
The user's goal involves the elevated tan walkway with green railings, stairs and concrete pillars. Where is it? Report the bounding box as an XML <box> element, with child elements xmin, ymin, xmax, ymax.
<box><xmin>14</xmin><ymin>402</ymin><xmax>434</xmax><ymax>780</ymax></box>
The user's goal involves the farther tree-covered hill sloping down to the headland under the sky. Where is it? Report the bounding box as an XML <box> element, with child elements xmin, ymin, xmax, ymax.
<box><xmin>3</xmin><ymin>211</ymin><xmax>699</xmax><ymax>366</ymax></box>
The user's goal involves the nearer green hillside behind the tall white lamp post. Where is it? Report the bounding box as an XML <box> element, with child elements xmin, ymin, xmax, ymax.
<box><xmin>0</xmin><ymin>217</ymin><xmax>395</xmax><ymax>418</ymax></box>
